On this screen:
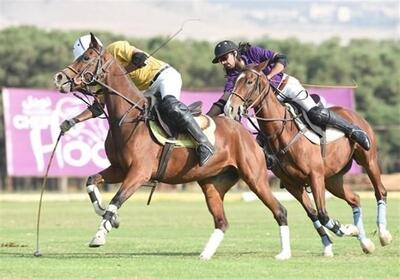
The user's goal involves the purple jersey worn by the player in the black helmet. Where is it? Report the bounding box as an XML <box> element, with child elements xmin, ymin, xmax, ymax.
<box><xmin>224</xmin><ymin>47</ymin><xmax>283</xmax><ymax>92</ymax></box>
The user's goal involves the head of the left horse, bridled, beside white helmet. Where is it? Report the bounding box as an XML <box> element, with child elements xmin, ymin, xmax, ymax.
<box><xmin>54</xmin><ymin>33</ymin><xmax>109</xmax><ymax>95</ymax></box>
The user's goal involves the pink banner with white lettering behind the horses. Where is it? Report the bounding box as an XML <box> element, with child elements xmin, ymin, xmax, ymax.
<box><xmin>3</xmin><ymin>88</ymin><xmax>354</xmax><ymax>177</ymax></box>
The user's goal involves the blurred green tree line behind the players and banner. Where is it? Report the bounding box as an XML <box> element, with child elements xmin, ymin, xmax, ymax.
<box><xmin>0</xmin><ymin>26</ymin><xmax>400</xmax><ymax>175</ymax></box>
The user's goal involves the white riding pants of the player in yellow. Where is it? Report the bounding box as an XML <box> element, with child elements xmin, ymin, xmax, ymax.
<box><xmin>144</xmin><ymin>66</ymin><xmax>182</xmax><ymax>100</ymax></box>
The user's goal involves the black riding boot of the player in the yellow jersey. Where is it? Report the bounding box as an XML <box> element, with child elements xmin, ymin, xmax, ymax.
<box><xmin>160</xmin><ymin>95</ymin><xmax>214</xmax><ymax>166</ymax></box>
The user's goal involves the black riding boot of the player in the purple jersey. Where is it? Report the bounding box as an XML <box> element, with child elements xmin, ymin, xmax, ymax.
<box><xmin>307</xmin><ymin>107</ymin><xmax>371</xmax><ymax>150</ymax></box>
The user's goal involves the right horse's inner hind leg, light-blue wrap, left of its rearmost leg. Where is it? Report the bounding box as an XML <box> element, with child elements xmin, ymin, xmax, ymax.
<box><xmin>325</xmin><ymin>174</ymin><xmax>375</xmax><ymax>254</ymax></box>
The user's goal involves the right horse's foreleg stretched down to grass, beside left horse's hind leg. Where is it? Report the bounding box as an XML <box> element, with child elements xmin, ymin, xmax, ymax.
<box><xmin>284</xmin><ymin>182</ymin><xmax>333</xmax><ymax>257</ymax></box>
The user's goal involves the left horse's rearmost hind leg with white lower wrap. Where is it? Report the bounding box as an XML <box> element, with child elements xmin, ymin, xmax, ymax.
<box><xmin>242</xmin><ymin>173</ymin><xmax>292</xmax><ymax>260</ymax></box>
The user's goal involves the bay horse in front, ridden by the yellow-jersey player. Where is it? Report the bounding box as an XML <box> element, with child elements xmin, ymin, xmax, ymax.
<box><xmin>54</xmin><ymin>34</ymin><xmax>291</xmax><ymax>260</ymax></box>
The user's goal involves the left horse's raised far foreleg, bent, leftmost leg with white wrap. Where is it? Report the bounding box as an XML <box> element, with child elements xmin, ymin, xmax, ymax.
<box><xmin>86</xmin><ymin>165</ymin><xmax>124</xmax><ymax>216</ymax></box>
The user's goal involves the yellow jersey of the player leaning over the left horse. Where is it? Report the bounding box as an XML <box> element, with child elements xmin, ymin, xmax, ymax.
<box><xmin>107</xmin><ymin>41</ymin><xmax>167</xmax><ymax>90</ymax></box>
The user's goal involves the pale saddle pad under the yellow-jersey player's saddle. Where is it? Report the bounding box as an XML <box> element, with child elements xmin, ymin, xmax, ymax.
<box><xmin>149</xmin><ymin>115</ymin><xmax>216</xmax><ymax>148</ymax></box>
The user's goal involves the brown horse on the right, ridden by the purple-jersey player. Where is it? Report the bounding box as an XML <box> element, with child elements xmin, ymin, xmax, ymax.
<box><xmin>225</xmin><ymin>62</ymin><xmax>392</xmax><ymax>256</ymax></box>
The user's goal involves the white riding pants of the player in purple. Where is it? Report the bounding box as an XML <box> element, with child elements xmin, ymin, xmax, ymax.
<box><xmin>276</xmin><ymin>74</ymin><xmax>317</xmax><ymax>111</ymax></box>
